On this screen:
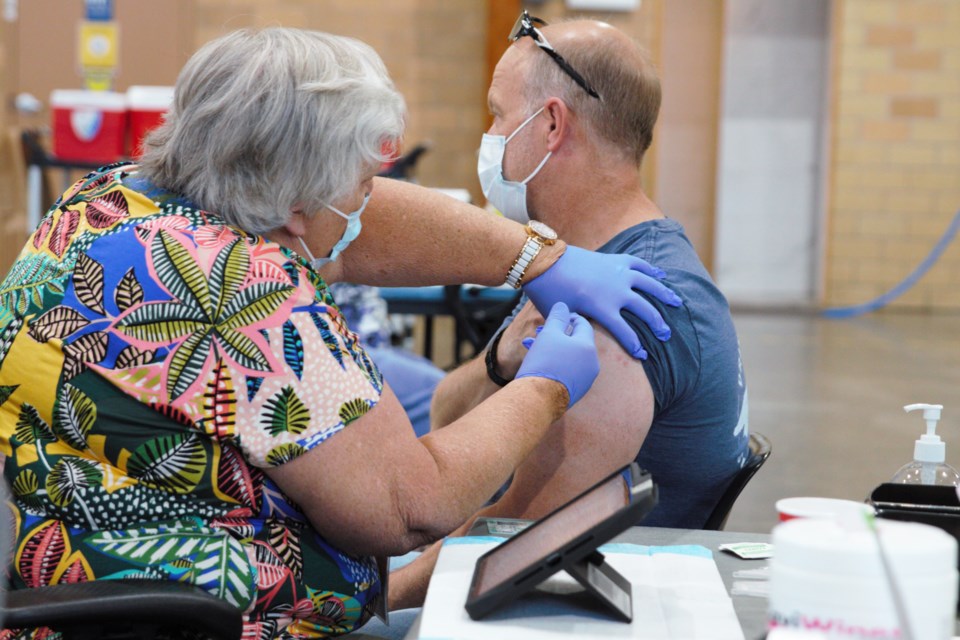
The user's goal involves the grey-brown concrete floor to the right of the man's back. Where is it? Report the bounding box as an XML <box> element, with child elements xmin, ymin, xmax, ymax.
<box><xmin>726</xmin><ymin>312</ymin><xmax>960</xmax><ymax>533</ymax></box>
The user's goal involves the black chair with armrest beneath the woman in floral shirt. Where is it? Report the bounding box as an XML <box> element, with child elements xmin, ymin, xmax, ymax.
<box><xmin>0</xmin><ymin>481</ymin><xmax>243</xmax><ymax>640</ymax></box>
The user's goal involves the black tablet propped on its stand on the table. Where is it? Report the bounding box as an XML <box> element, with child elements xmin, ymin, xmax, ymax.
<box><xmin>466</xmin><ymin>463</ymin><xmax>657</xmax><ymax>622</ymax></box>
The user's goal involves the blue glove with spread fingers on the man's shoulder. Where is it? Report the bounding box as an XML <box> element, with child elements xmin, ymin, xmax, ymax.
<box><xmin>523</xmin><ymin>246</ymin><xmax>683</xmax><ymax>360</ymax></box>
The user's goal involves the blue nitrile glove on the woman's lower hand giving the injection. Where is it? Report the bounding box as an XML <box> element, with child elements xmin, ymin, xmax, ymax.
<box><xmin>517</xmin><ymin>302</ymin><xmax>600</xmax><ymax>409</ymax></box>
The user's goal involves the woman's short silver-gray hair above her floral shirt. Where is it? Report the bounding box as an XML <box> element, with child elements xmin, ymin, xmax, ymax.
<box><xmin>140</xmin><ymin>27</ymin><xmax>405</xmax><ymax>234</ymax></box>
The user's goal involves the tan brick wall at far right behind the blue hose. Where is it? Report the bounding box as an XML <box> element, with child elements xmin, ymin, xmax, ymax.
<box><xmin>825</xmin><ymin>0</ymin><xmax>960</xmax><ymax>310</ymax></box>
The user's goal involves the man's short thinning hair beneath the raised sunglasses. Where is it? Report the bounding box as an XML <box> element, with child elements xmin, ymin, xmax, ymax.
<box><xmin>524</xmin><ymin>29</ymin><xmax>660</xmax><ymax>166</ymax></box>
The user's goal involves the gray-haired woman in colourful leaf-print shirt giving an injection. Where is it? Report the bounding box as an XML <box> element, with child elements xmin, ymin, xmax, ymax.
<box><xmin>0</xmin><ymin>28</ymin><xmax>672</xmax><ymax>638</ymax></box>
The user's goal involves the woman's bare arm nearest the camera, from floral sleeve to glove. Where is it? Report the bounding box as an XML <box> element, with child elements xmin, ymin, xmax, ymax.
<box><xmin>269</xmin><ymin>377</ymin><xmax>569</xmax><ymax>555</ymax></box>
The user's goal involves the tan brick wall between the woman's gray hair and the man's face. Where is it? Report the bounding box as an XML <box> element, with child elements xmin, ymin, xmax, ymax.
<box><xmin>195</xmin><ymin>0</ymin><xmax>486</xmax><ymax>199</ymax></box>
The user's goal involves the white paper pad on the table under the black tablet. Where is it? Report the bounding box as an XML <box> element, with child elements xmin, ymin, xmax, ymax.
<box><xmin>419</xmin><ymin>538</ymin><xmax>743</xmax><ymax>640</ymax></box>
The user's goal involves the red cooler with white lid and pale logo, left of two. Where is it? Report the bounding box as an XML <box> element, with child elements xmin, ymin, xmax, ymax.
<box><xmin>50</xmin><ymin>89</ymin><xmax>127</xmax><ymax>163</ymax></box>
